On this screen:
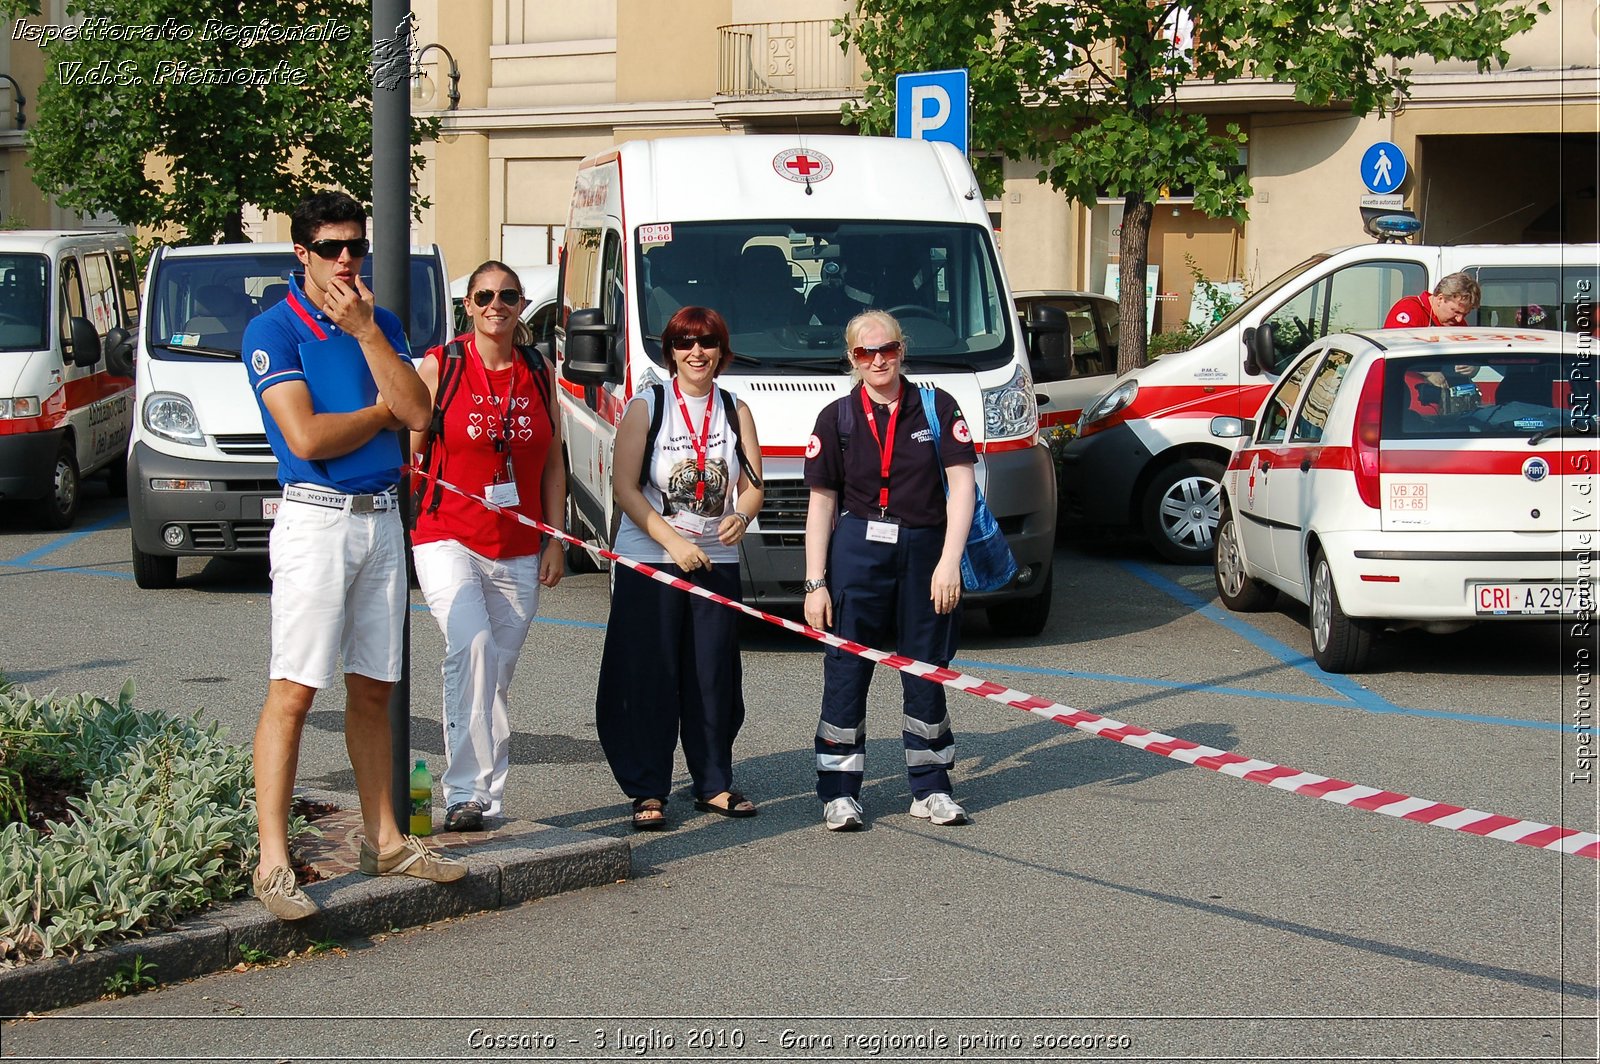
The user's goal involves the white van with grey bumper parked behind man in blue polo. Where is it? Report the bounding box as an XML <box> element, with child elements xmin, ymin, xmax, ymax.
<box><xmin>128</xmin><ymin>243</ymin><xmax>450</xmax><ymax>589</ymax></box>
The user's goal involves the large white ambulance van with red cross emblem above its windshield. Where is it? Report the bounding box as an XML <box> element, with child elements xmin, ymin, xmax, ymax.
<box><xmin>555</xmin><ymin>136</ymin><xmax>1056</xmax><ymax>634</ymax></box>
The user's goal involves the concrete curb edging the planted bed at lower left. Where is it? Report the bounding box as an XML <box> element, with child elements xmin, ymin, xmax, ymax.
<box><xmin>0</xmin><ymin>822</ymin><xmax>632</xmax><ymax>1019</ymax></box>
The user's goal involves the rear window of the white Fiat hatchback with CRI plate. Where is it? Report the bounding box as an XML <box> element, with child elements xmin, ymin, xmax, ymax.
<box><xmin>1382</xmin><ymin>350</ymin><xmax>1600</xmax><ymax>440</ymax></box>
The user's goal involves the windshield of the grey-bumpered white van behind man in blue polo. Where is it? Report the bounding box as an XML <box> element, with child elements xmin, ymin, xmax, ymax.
<box><xmin>144</xmin><ymin>251</ymin><xmax>450</xmax><ymax>360</ymax></box>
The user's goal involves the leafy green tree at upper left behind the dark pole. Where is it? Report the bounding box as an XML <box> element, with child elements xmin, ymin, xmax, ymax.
<box><xmin>0</xmin><ymin>0</ymin><xmax>437</xmax><ymax>243</ymax></box>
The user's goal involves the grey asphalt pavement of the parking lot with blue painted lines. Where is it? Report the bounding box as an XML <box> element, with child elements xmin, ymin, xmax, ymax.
<box><xmin>0</xmin><ymin>483</ymin><xmax>1600</xmax><ymax>1061</ymax></box>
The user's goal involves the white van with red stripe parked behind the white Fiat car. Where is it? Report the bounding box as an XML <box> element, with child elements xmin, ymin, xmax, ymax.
<box><xmin>1061</xmin><ymin>243</ymin><xmax>1600</xmax><ymax>565</ymax></box>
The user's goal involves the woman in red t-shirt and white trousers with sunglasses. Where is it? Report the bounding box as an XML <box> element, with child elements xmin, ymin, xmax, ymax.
<box><xmin>411</xmin><ymin>261</ymin><xmax>566</xmax><ymax>830</ymax></box>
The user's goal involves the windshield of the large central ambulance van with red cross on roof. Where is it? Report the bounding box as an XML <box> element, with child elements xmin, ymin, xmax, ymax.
<box><xmin>637</xmin><ymin>221</ymin><xmax>1016</xmax><ymax>373</ymax></box>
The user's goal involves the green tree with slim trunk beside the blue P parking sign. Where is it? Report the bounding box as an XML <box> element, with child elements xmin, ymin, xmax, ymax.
<box><xmin>837</xmin><ymin>0</ymin><xmax>1549</xmax><ymax>373</ymax></box>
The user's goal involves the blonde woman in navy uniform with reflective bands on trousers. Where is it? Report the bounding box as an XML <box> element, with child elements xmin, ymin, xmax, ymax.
<box><xmin>805</xmin><ymin>310</ymin><xmax>978</xmax><ymax>830</ymax></box>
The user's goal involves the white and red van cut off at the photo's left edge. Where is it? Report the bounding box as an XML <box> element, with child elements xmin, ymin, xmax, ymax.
<box><xmin>0</xmin><ymin>230</ymin><xmax>139</xmax><ymax>528</ymax></box>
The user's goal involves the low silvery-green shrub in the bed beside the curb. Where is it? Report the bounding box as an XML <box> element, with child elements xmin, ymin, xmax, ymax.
<box><xmin>0</xmin><ymin>682</ymin><xmax>315</xmax><ymax>965</ymax></box>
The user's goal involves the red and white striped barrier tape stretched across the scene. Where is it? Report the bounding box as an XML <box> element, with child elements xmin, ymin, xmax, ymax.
<box><xmin>419</xmin><ymin>474</ymin><xmax>1600</xmax><ymax>859</ymax></box>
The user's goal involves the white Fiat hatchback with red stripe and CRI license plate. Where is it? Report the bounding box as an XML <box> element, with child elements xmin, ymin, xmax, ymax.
<box><xmin>1211</xmin><ymin>328</ymin><xmax>1600</xmax><ymax>672</ymax></box>
